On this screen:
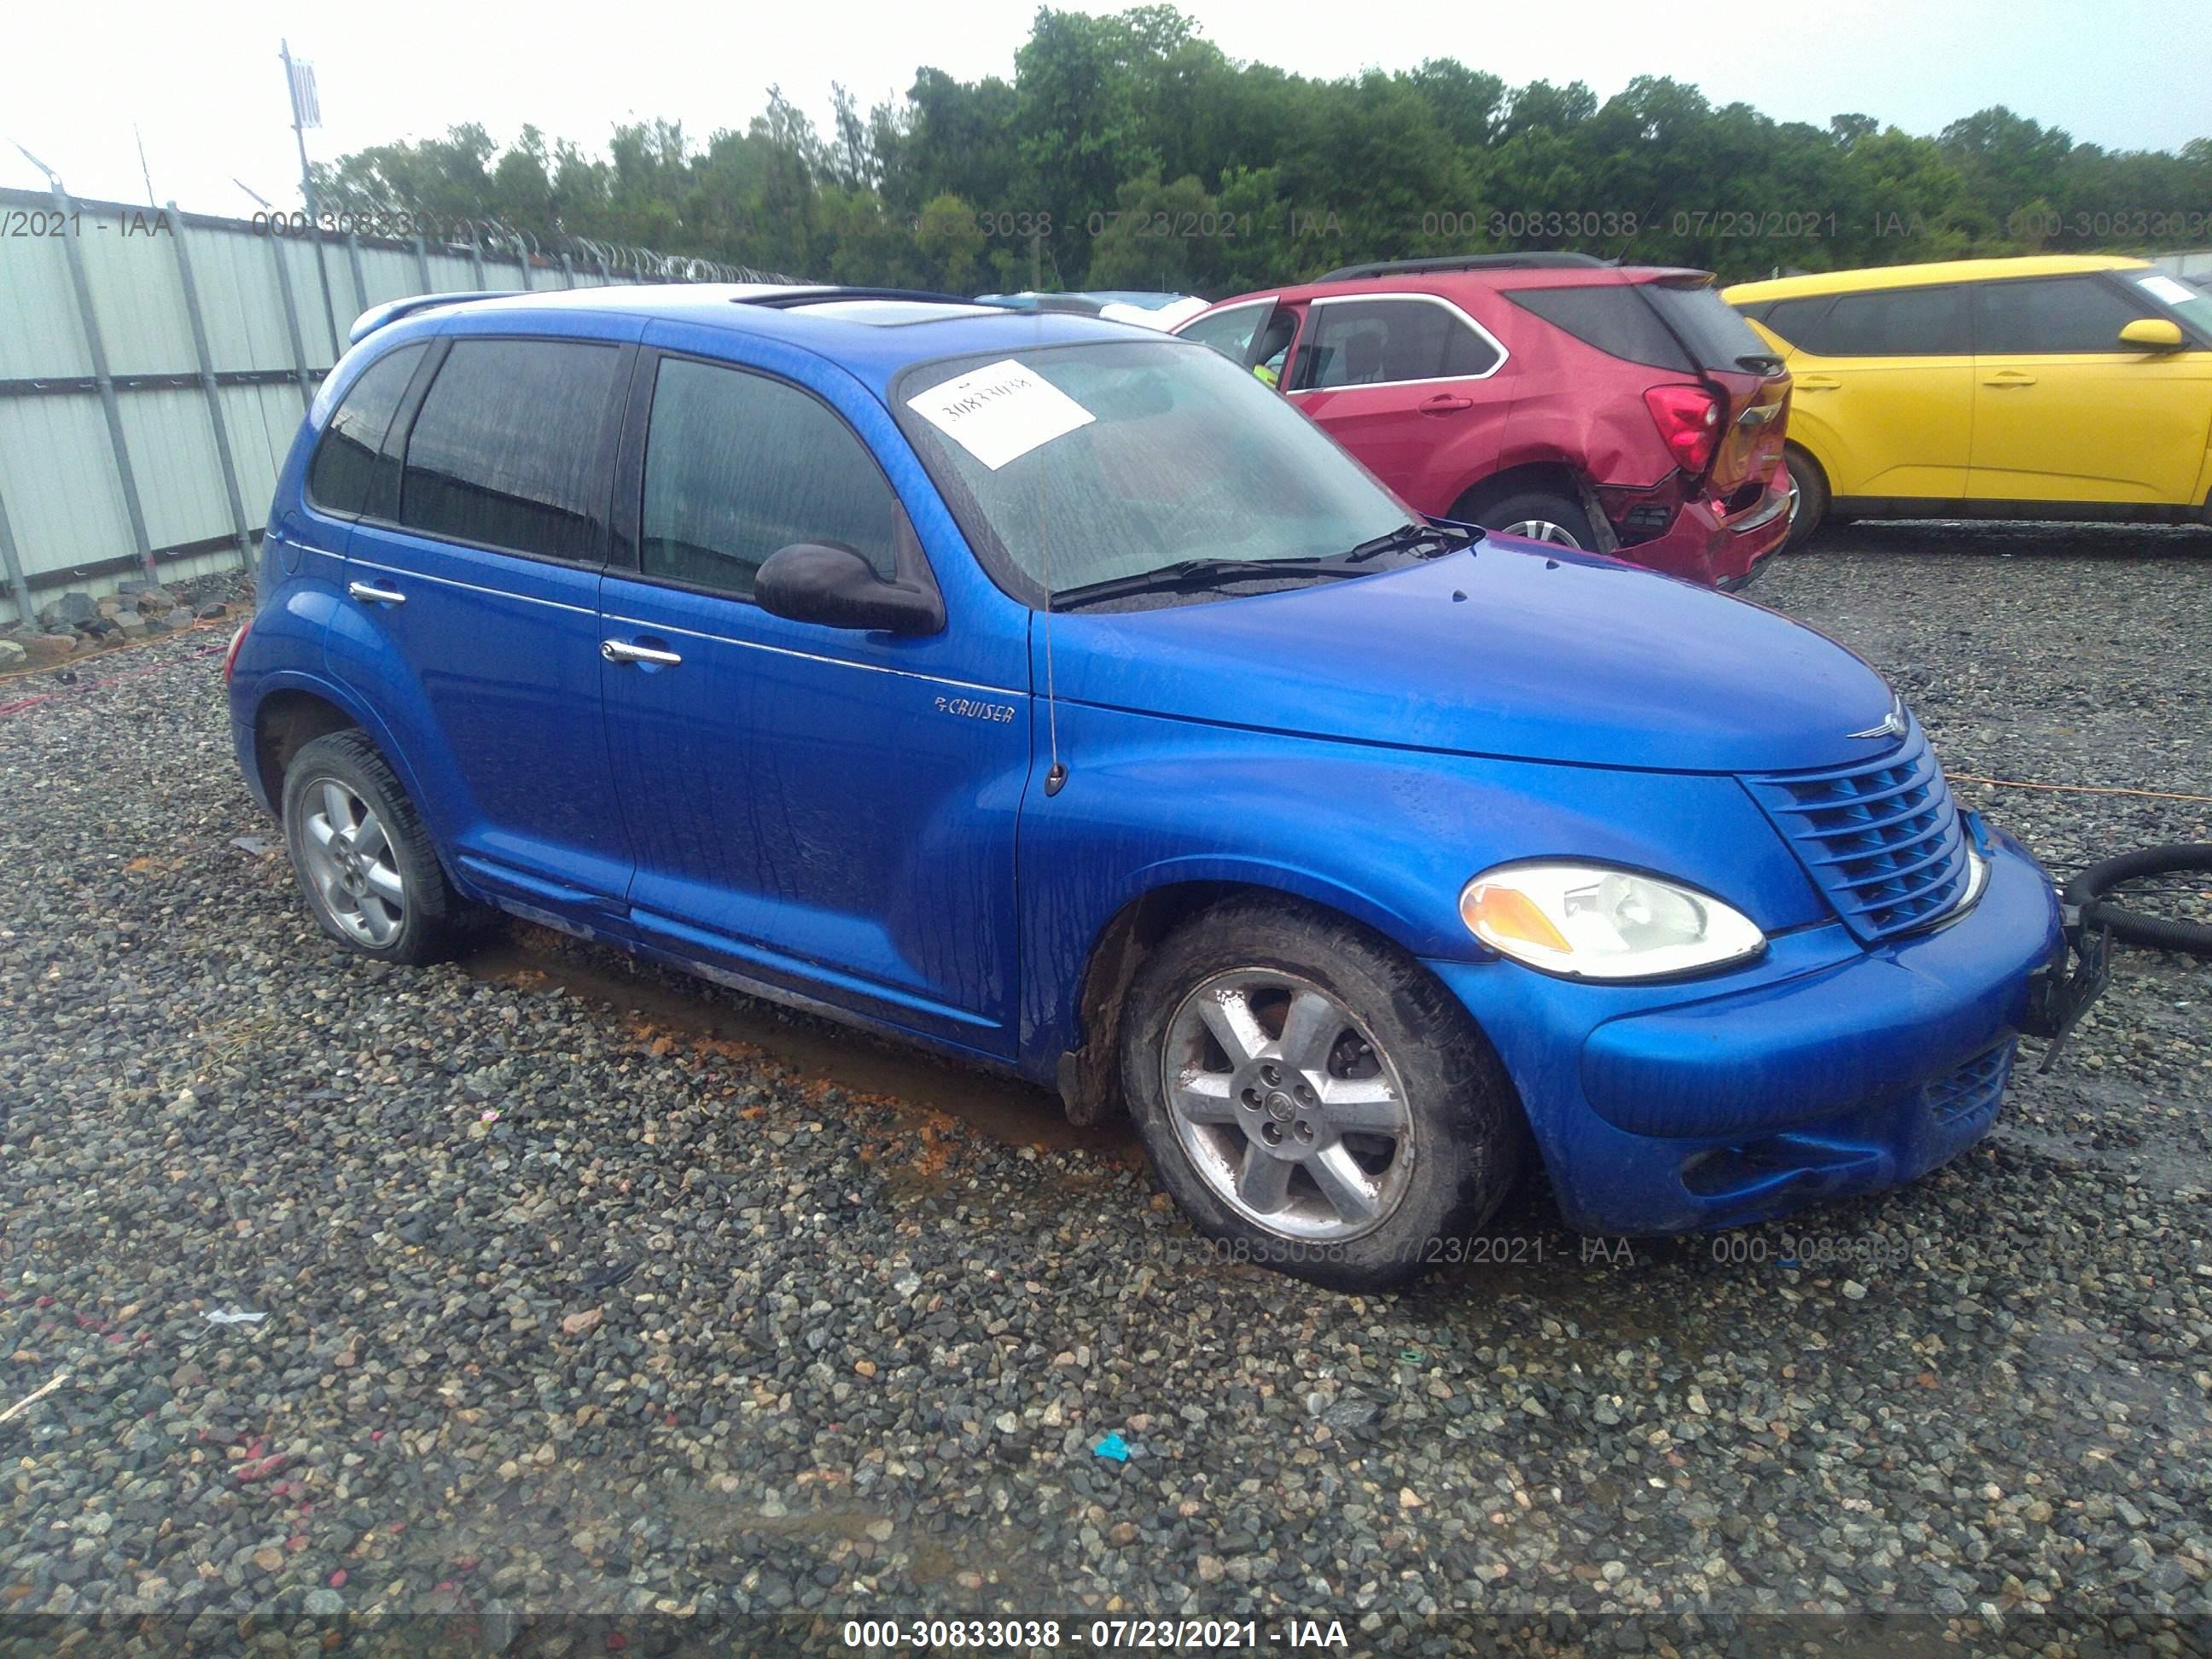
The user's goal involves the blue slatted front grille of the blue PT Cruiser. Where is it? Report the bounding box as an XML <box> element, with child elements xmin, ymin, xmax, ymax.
<box><xmin>1745</xmin><ymin>719</ymin><xmax>1966</xmax><ymax>945</ymax></box>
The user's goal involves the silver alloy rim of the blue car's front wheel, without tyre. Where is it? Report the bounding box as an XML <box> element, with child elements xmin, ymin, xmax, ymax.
<box><xmin>1161</xmin><ymin>969</ymin><xmax>1413</xmax><ymax>1241</ymax></box>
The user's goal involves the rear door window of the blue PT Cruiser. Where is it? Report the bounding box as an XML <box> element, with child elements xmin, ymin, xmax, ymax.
<box><xmin>400</xmin><ymin>339</ymin><xmax>621</xmax><ymax>562</ymax></box>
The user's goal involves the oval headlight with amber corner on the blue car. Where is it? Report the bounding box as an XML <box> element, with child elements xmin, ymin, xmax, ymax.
<box><xmin>1460</xmin><ymin>863</ymin><xmax>1767</xmax><ymax>980</ymax></box>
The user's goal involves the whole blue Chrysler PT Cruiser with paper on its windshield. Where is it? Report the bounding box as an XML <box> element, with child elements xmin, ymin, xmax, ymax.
<box><xmin>230</xmin><ymin>288</ymin><xmax>2066</xmax><ymax>1288</ymax></box>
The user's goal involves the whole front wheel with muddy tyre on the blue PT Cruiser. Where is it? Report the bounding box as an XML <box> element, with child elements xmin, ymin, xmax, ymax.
<box><xmin>1121</xmin><ymin>900</ymin><xmax>1524</xmax><ymax>1289</ymax></box>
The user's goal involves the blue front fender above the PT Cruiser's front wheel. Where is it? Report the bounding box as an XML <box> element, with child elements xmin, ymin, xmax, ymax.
<box><xmin>1020</xmin><ymin>703</ymin><xmax>1827</xmax><ymax>1077</ymax></box>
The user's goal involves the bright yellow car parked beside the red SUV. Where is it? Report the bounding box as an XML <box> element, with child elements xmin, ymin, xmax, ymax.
<box><xmin>1723</xmin><ymin>257</ymin><xmax>2212</xmax><ymax>544</ymax></box>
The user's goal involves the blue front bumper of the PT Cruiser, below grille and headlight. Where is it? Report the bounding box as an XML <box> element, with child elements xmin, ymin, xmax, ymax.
<box><xmin>1431</xmin><ymin>836</ymin><xmax>2064</xmax><ymax>1234</ymax></box>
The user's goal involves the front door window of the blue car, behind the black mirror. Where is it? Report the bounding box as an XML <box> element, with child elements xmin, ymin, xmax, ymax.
<box><xmin>639</xmin><ymin>356</ymin><xmax>898</xmax><ymax>595</ymax></box>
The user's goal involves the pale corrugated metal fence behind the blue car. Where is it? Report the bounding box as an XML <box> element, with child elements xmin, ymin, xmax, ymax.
<box><xmin>0</xmin><ymin>190</ymin><xmax>788</xmax><ymax>624</ymax></box>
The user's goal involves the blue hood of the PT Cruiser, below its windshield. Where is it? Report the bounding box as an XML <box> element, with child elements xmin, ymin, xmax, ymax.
<box><xmin>1031</xmin><ymin>539</ymin><xmax>1891</xmax><ymax>772</ymax></box>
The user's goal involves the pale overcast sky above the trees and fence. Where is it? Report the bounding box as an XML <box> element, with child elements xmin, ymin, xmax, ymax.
<box><xmin>0</xmin><ymin>0</ymin><xmax>2212</xmax><ymax>214</ymax></box>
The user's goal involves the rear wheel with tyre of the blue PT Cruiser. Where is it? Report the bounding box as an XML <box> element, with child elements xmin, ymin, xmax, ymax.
<box><xmin>283</xmin><ymin>732</ymin><xmax>463</xmax><ymax>963</ymax></box>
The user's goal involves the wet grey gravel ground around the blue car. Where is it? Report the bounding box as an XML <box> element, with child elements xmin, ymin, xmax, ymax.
<box><xmin>0</xmin><ymin>527</ymin><xmax>2212</xmax><ymax>1652</ymax></box>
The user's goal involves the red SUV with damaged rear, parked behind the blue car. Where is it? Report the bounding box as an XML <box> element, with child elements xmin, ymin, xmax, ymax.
<box><xmin>1174</xmin><ymin>254</ymin><xmax>1790</xmax><ymax>588</ymax></box>
